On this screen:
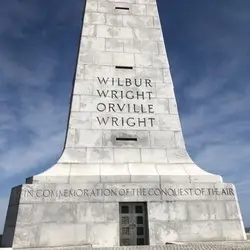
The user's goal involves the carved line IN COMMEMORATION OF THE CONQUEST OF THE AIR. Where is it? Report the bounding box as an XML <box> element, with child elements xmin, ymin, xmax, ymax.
<box><xmin>21</xmin><ymin>187</ymin><xmax>234</xmax><ymax>198</ymax></box>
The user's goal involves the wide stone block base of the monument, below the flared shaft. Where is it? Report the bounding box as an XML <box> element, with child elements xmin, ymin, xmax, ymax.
<box><xmin>2</xmin><ymin>183</ymin><xmax>246</xmax><ymax>248</ymax></box>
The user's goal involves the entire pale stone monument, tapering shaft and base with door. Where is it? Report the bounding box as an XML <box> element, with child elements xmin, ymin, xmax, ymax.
<box><xmin>2</xmin><ymin>0</ymin><xmax>245</xmax><ymax>248</ymax></box>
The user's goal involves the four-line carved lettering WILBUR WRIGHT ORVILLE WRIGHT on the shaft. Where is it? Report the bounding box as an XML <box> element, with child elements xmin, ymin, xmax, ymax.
<box><xmin>96</xmin><ymin>77</ymin><xmax>155</xmax><ymax>128</ymax></box>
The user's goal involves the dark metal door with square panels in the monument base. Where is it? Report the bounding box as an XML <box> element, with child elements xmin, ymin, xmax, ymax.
<box><xmin>120</xmin><ymin>202</ymin><xmax>148</xmax><ymax>246</ymax></box>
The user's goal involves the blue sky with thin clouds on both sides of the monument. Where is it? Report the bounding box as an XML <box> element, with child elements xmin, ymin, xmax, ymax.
<box><xmin>0</xmin><ymin>0</ymin><xmax>250</xmax><ymax>232</ymax></box>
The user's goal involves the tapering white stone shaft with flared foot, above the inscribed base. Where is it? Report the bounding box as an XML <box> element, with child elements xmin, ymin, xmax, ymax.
<box><xmin>32</xmin><ymin>0</ymin><xmax>222</xmax><ymax>183</ymax></box>
